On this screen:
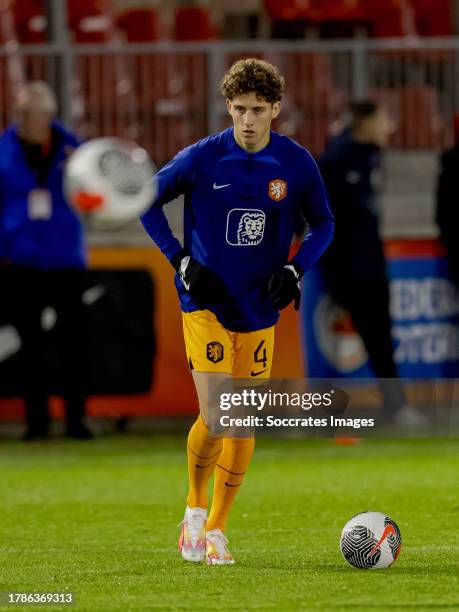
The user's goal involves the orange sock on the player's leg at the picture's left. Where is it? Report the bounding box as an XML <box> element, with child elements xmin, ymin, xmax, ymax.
<box><xmin>187</xmin><ymin>415</ymin><xmax>223</xmax><ymax>508</ymax></box>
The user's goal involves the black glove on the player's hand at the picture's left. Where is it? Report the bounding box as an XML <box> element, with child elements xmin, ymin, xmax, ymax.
<box><xmin>171</xmin><ymin>251</ymin><xmax>231</xmax><ymax>306</ymax></box>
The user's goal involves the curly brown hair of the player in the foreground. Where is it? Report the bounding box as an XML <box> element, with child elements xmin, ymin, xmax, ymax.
<box><xmin>220</xmin><ymin>57</ymin><xmax>285</xmax><ymax>104</ymax></box>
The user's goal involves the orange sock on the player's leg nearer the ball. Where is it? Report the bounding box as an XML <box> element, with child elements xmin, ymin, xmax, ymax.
<box><xmin>207</xmin><ymin>438</ymin><xmax>255</xmax><ymax>531</ymax></box>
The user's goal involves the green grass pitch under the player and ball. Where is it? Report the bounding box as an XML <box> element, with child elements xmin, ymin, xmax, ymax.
<box><xmin>0</xmin><ymin>435</ymin><xmax>459</xmax><ymax>612</ymax></box>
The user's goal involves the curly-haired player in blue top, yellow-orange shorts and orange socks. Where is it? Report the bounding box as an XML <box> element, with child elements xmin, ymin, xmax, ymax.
<box><xmin>142</xmin><ymin>59</ymin><xmax>333</xmax><ymax>565</ymax></box>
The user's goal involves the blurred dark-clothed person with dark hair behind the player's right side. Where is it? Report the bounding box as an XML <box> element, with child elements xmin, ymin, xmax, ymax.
<box><xmin>319</xmin><ymin>101</ymin><xmax>426</xmax><ymax>425</ymax></box>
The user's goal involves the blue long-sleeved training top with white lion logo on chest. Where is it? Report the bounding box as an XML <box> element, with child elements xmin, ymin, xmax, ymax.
<box><xmin>142</xmin><ymin>128</ymin><xmax>333</xmax><ymax>332</ymax></box>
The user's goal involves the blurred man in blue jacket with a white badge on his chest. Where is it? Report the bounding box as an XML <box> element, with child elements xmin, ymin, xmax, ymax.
<box><xmin>0</xmin><ymin>81</ymin><xmax>91</xmax><ymax>439</ymax></box>
